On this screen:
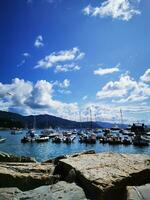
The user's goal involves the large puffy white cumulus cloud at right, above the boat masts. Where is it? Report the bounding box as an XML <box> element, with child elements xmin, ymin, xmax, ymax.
<box><xmin>96</xmin><ymin>74</ymin><xmax>150</xmax><ymax>103</ymax></box>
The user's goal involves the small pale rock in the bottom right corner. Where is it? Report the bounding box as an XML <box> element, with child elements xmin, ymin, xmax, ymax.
<box><xmin>127</xmin><ymin>184</ymin><xmax>150</xmax><ymax>200</ymax></box>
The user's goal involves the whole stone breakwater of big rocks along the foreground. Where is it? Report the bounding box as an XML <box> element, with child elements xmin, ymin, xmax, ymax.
<box><xmin>0</xmin><ymin>151</ymin><xmax>150</xmax><ymax>200</ymax></box>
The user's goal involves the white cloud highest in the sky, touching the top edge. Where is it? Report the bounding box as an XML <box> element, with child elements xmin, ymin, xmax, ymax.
<box><xmin>83</xmin><ymin>0</ymin><xmax>141</xmax><ymax>21</ymax></box>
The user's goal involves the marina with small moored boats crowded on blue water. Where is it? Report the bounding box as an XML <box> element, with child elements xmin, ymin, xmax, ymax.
<box><xmin>0</xmin><ymin>124</ymin><xmax>150</xmax><ymax>161</ymax></box>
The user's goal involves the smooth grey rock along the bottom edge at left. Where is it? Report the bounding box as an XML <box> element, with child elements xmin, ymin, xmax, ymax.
<box><xmin>0</xmin><ymin>181</ymin><xmax>86</xmax><ymax>200</ymax></box>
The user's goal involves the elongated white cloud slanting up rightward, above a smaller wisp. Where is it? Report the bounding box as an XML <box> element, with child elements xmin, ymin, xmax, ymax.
<box><xmin>34</xmin><ymin>47</ymin><xmax>85</xmax><ymax>69</ymax></box>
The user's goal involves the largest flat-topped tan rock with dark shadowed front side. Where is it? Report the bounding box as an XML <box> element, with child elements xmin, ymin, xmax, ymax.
<box><xmin>55</xmin><ymin>153</ymin><xmax>150</xmax><ymax>200</ymax></box>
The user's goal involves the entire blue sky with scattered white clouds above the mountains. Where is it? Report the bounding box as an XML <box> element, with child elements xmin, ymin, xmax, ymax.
<box><xmin>0</xmin><ymin>0</ymin><xmax>150</xmax><ymax>124</ymax></box>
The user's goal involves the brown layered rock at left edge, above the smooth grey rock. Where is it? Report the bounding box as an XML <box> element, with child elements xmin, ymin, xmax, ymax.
<box><xmin>0</xmin><ymin>162</ymin><xmax>58</xmax><ymax>190</ymax></box>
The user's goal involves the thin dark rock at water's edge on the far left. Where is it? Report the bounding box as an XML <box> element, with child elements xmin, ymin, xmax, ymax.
<box><xmin>0</xmin><ymin>151</ymin><xmax>36</xmax><ymax>163</ymax></box>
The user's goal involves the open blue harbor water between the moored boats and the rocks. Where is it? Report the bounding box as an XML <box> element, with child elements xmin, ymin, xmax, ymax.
<box><xmin>0</xmin><ymin>130</ymin><xmax>150</xmax><ymax>161</ymax></box>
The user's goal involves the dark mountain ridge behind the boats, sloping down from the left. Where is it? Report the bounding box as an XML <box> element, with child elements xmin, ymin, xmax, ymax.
<box><xmin>0</xmin><ymin>111</ymin><xmax>101</xmax><ymax>128</ymax></box>
